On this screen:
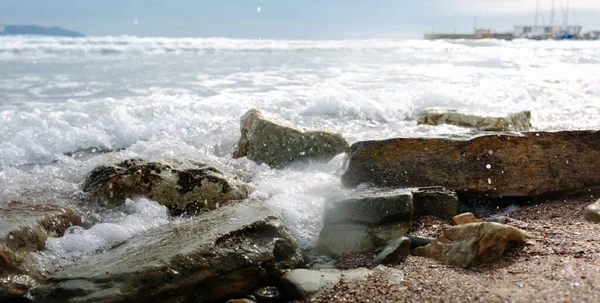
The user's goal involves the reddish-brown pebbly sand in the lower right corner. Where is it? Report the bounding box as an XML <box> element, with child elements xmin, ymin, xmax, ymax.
<box><xmin>315</xmin><ymin>197</ymin><xmax>600</xmax><ymax>302</ymax></box>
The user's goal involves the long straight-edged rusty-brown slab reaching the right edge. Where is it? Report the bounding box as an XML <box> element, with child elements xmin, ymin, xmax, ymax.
<box><xmin>342</xmin><ymin>131</ymin><xmax>600</xmax><ymax>198</ymax></box>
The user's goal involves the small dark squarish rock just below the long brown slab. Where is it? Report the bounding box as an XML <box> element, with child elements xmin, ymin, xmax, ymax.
<box><xmin>413</xmin><ymin>186</ymin><xmax>458</xmax><ymax>219</ymax></box>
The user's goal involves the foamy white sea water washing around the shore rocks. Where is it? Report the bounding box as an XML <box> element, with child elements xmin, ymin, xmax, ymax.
<box><xmin>0</xmin><ymin>36</ymin><xmax>600</xmax><ymax>260</ymax></box>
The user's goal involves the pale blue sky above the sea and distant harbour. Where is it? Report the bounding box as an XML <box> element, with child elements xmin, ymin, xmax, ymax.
<box><xmin>0</xmin><ymin>0</ymin><xmax>600</xmax><ymax>39</ymax></box>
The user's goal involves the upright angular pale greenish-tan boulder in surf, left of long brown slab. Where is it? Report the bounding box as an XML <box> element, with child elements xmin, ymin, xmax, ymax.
<box><xmin>233</xmin><ymin>109</ymin><xmax>349</xmax><ymax>168</ymax></box>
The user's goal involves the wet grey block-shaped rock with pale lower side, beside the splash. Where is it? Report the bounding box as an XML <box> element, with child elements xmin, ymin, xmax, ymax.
<box><xmin>317</xmin><ymin>189</ymin><xmax>414</xmax><ymax>258</ymax></box>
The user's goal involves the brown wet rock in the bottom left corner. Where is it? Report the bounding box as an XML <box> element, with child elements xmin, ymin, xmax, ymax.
<box><xmin>0</xmin><ymin>201</ymin><xmax>82</xmax><ymax>302</ymax></box>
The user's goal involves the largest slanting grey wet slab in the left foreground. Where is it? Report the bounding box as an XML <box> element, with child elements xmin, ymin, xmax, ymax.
<box><xmin>34</xmin><ymin>201</ymin><xmax>302</xmax><ymax>302</ymax></box>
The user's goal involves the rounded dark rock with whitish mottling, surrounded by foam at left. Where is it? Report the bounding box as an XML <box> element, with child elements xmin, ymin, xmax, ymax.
<box><xmin>82</xmin><ymin>159</ymin><xmax>253</xmax><ymax>213</ymax></box>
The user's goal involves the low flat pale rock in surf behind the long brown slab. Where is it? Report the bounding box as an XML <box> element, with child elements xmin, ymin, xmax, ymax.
<box><xmin>417</xmin><ymin>109</ymin><xmax>531</xmax><ymax>131</ymax></box>
